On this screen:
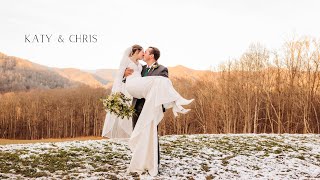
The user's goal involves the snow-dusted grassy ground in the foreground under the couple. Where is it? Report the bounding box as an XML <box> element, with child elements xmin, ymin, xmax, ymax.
<box><xmin>0</xmin><ymin>134</ymin><xmax>320</xmax><ymax>180</ymax></box>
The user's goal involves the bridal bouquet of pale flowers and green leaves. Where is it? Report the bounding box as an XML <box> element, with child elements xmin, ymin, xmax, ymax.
<box><xmin>101</xmin><ymin>92</ymin><xmax>135</xmax><ymax>119</ymax></box>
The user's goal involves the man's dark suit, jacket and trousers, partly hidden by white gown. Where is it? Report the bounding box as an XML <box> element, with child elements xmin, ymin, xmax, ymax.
<box><xmin>132</xmin><ymin>62</ymin><xmax>168</xmax><ymax>164</ymax></box>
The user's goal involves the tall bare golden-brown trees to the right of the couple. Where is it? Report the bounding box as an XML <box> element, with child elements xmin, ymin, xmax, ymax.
<box><xmin>160</xmin><ymin>37</ymin><xmax>320</xmax><ymax>134</ymax></box>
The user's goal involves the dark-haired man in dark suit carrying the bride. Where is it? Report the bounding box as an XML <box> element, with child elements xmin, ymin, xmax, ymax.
<box><xmin>124</xmin><ymin>47</ymin><xmax>168</xmax><ymax>167</ymax></box>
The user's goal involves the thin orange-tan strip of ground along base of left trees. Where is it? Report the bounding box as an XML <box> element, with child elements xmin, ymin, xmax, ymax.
<box><xmin>0</xmin><ymin>136</ymin><xmax>107</xmax><ymax>145</ymax></box>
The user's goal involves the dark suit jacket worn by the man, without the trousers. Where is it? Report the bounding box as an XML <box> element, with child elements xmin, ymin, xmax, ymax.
<box><xmin>132</xmin><ymin>62</ymin><xmax>169</xmax><ymax>112</ymax></box>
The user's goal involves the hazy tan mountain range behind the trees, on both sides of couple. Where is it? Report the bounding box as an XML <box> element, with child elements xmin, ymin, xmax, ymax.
<box><xmin>0</xmin><ymin>53</ymin><xmax>207</xmax><ymax>92</ymax></box>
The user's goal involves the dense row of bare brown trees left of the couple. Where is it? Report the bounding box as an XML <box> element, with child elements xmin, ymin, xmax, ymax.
<box><xmin>0</xmin><ymin>86</ymin><xmax>108</xmax><ymax>139</ymax></box>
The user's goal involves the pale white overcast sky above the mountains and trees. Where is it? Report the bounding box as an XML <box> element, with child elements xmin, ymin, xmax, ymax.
<box><xmin>0</xmin><ymin>0</ymin><xmax>320</xmax><ymax>70</ymax></box>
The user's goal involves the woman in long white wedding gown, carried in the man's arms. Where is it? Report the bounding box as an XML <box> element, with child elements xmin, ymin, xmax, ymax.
<box><xmin>105</xmin><ymin>45</ymin><xmax>193</xmax><ymax>176</ymax></box>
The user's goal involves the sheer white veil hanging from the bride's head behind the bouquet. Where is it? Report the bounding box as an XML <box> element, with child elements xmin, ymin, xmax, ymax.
<box><xmin>102</xmin><ymin>47</ymin><xmax>132</xmax><ymax>138</ymax></box>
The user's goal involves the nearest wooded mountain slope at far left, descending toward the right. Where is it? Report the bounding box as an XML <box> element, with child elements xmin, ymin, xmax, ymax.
<box><xmin>0</xmin><ymin>53</ymin><xmax>79</xmax><ymax>92</ymax></box>
